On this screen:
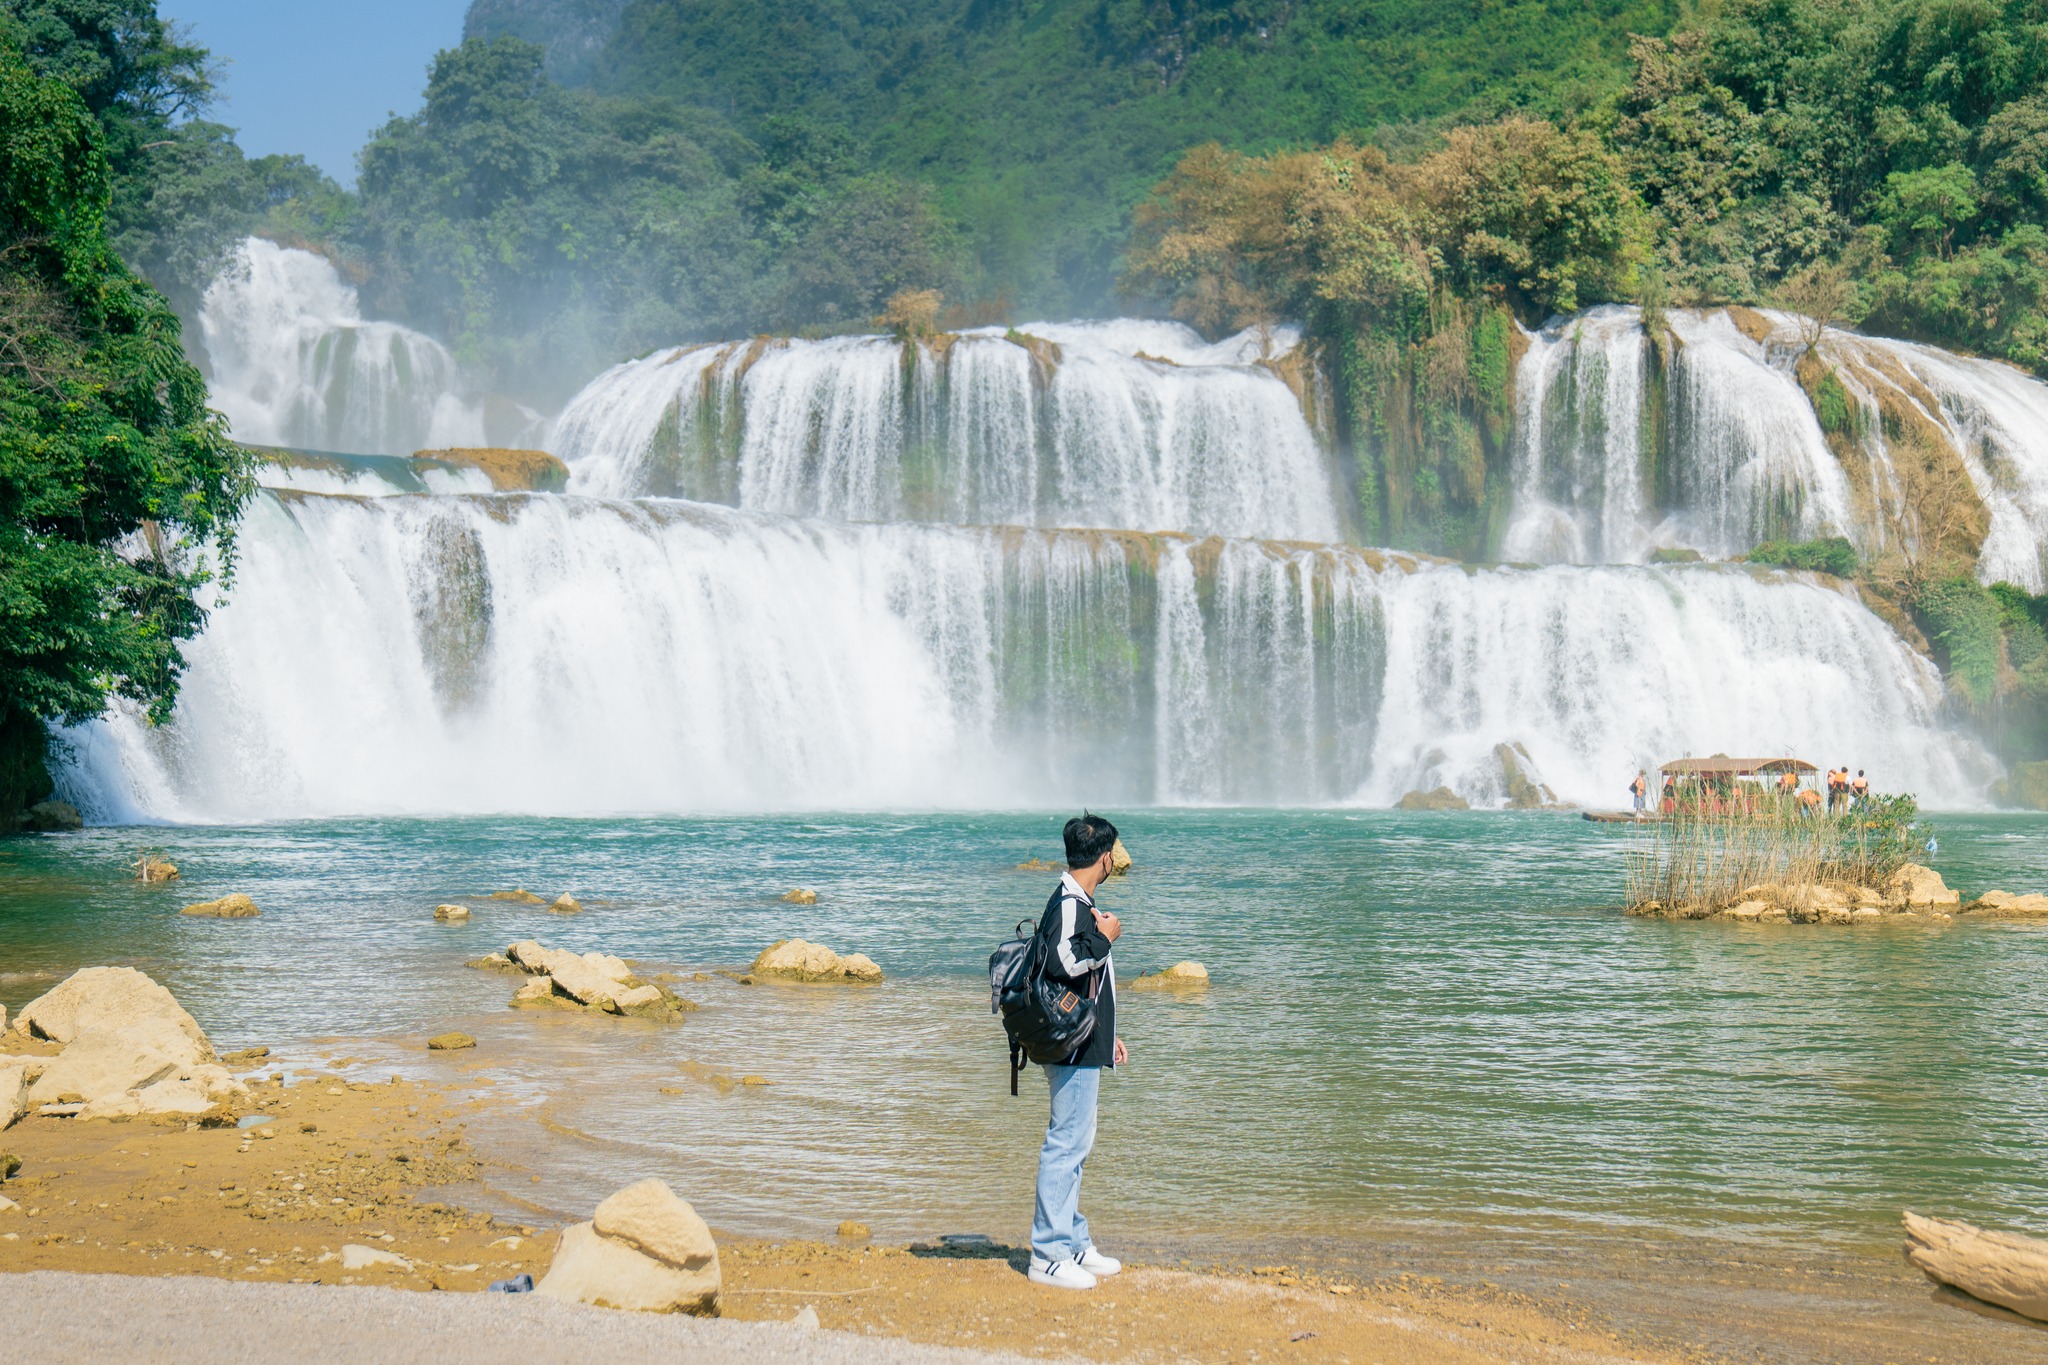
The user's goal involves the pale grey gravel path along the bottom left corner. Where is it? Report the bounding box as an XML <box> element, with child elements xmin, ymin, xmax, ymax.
<box><xmin>0</xmin><ymin>1271</ymin><xmax>1022</xmax><ymax>1365</ymax></box>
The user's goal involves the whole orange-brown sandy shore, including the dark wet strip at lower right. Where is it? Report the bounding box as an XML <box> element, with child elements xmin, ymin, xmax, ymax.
<box><xmin>0</xmin><ymin>1040</ymin><xmax>2048</xmax><ymax>1363</ymax></box>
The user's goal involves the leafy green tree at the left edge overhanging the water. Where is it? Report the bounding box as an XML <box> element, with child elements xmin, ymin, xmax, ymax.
<box><xmin>0</xmin><ymin>43</ymin><xmax>252</xmax><ymax>817</ymax></box>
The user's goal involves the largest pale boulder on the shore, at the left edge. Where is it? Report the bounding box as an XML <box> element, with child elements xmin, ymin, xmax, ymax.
<box><xmin>0</xmin><ymin>966</ymin><xmax>250</xmax><ymax>1128</ymax></box>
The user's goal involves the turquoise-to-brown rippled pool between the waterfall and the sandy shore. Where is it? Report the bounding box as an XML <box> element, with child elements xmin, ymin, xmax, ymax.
<box><xmin>0</xmin><ymin>810</ymin><xmax>2048</xmax><ymax>1257</ymax></box>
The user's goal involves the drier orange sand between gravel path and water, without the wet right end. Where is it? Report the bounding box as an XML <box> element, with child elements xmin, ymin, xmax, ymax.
<box><xmin>0</xmin><ymin>1044</ymin><xmax>1677</xmax><ymax>1361</ymax></box>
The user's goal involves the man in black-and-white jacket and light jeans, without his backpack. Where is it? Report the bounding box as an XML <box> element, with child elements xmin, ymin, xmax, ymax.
<box><xmin>1030</xmin><ymin>814</ymin><xmax>1128</xmax><ymax>1289</ymax></box>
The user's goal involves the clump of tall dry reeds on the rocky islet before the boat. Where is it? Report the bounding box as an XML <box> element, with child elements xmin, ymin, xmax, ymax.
<box><xmin>1628</xmin><ymin>796</ymin><xmax>1931</xmax><ymax>915</ymax></box>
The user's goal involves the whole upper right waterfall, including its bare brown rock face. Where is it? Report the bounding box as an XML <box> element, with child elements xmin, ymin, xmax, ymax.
<box><xmin>1501</xmin><ymin>307</ymin><xmax>2048</xmax><ymax>591</ymax></box>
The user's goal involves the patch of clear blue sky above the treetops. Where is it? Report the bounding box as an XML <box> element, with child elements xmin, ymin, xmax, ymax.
<box><xmin>158</xmin><ymin>0</ymin><xmax>469</xmax><ymax>184</ymax></box>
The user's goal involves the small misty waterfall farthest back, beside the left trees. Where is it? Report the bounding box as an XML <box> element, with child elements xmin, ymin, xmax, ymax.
<box><xmin>199</xmin><ymin>237</ymin><xmax>485</xmax><ymax>454</ymax></box>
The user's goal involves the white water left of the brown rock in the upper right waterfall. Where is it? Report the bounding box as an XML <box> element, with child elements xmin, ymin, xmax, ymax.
<box><xmin>1501</xmin><ymin>305</ymin><xmax>1866</xmax><ymax>563</ymax></box>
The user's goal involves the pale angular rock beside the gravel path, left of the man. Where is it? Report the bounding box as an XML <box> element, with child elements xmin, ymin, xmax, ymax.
<box><xmin>535</xmin><ymin>1181</ymin><xmax>721</xmax><ymax>1316</ymax></box>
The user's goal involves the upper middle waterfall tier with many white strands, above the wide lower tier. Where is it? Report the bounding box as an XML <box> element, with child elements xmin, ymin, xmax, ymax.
<box><xmin>553</xmin><ymin>321</ymin><xmax>1343</xmax><ymax>542</ymax></box>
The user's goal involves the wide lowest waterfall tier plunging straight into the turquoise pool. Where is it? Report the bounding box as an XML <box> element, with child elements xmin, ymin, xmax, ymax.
<box><xmin>63</xmin><ymin>493</ymin><xmax>1993</xmax><ymax>821</ymax></box>
